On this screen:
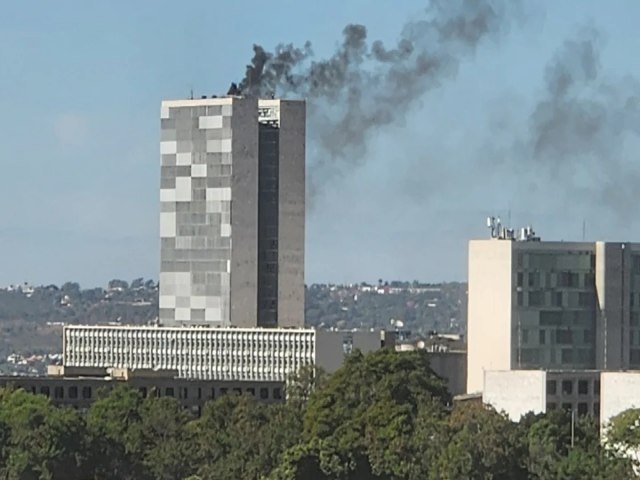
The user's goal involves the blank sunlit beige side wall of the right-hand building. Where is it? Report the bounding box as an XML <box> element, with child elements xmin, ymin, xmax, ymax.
<box><xmin>467</xmin><ymin>240</ymin><xmax>513</xmax><ymax>393</ymax></box>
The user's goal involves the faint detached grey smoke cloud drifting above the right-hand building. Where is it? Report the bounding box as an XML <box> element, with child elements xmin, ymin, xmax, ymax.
<box><xmin>528</xmin><ymin>27</ymin><xmax>640</xmax><ymax>209</ymax></box>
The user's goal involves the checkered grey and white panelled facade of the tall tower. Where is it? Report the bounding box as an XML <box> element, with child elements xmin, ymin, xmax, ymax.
<box><xmin>160</xmin><ymin>101</ymin><xmax>233</xmax><ymax>325</ymax></box>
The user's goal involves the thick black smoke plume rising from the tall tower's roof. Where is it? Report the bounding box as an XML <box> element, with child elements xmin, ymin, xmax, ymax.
<box><xmin>238</xmin><ymin>0</ymin><xmax>516</xmax><ymax>180</ymax></box>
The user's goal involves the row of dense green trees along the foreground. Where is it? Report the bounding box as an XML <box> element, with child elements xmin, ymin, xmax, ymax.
<box><xmin>0</xmin><ymin>351</ymin><xmax>639</xmax><ymax>480</ymax></box>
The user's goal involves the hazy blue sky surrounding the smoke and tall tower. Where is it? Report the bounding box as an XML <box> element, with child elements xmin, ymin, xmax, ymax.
<box><xmin>0</xmin><ymin>0</ymin><xmax>640</xmax><ymax>287</ymax></box>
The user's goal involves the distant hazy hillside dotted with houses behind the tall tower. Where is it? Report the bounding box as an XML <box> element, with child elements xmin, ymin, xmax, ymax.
<box><xmin>0</xmin><ymin>278</ymin><xmax>466</xmax><ymax>363</ymax></box>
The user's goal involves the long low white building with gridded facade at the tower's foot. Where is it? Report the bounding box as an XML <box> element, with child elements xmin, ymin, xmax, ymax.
<box><xmin>63</xmin><ymin>325</ymin><xmax>395</xmax><ymax>382</ymax></box>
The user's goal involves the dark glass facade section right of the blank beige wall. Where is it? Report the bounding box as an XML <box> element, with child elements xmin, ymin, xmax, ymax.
<box><xmin>513</xmin><ymin>250</ymin><xmax>597</xmax><ymax>369</ymax></box>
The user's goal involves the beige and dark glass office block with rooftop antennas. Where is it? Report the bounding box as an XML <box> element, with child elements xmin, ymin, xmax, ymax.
<box><xmin>467</xmin><ymin>221</ymin><xmax>640</xmax><ymax>393</ymax></box>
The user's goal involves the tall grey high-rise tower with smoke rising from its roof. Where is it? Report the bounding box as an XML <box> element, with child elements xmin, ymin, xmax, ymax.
<box><xmin>160</xmin><ymin>96</ymin><xmax>305</xmax><ymax>327</ymax></box>
